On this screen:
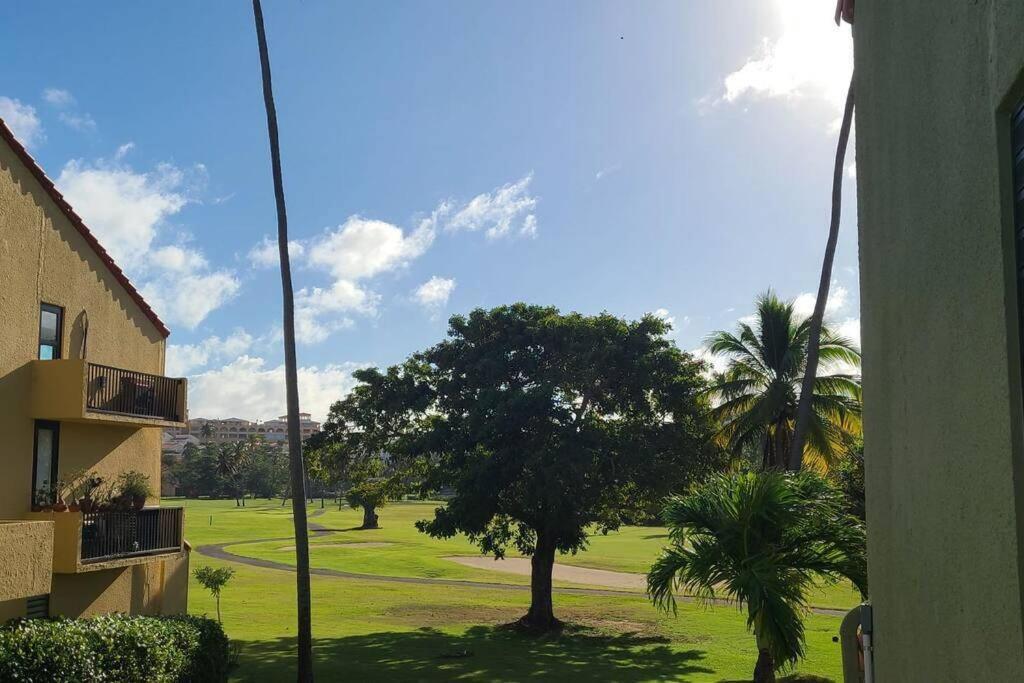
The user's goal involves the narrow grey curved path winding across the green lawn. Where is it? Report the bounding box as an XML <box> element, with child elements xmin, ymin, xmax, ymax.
<box><xmin>196</xmin><ymin>509</ymin><xmax>849</xmax><ymax>616</ymax></box>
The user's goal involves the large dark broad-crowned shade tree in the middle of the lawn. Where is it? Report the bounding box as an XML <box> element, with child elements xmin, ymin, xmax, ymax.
<box><xmin>414</xmin><ymin>304</ymin><xmax>716</xmax><ymax>631</ymax></box>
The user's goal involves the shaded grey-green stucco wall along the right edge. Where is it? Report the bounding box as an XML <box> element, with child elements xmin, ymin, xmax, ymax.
<box><xmin>854</xmin><ymin>0</ymin><xmax>1024</xmax><ymax>683</ymax></box>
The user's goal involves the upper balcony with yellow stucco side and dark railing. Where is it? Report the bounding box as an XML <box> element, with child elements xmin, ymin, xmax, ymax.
<box><xmin>31</xmin><ymin>358</ymin><xmax>187</xmax><ymax>428</ymax></box>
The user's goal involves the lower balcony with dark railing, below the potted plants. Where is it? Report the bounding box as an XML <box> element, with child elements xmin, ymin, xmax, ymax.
<box><xmin>29</xmin><ymin>508</ymin><xmax>184</xmax><ymax>573</ymax></box>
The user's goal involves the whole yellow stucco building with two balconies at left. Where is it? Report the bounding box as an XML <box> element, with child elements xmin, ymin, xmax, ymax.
<box><xmin>0</xmin><ymin>122</ymin><xmax>188</xmax><ymax>622</ymax></box>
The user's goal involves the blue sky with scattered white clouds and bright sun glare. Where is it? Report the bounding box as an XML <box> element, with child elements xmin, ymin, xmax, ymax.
<box><xmin>0</xmin><ymin>0</ymin><xmax>860</xmax><ymax>420</ymax></box>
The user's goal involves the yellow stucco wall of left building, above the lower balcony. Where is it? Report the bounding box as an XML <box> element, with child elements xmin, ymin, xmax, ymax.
<box><xmin>0</xmin><ymin>132</ymin><xmax>164</xmax><ymax>518</ymax></box>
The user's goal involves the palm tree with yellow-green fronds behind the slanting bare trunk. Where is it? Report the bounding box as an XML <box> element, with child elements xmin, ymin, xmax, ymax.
<box><xmin>707</xmin><ymin>291</ymin><xmax>860</xmax><ymax>469</ymax></box>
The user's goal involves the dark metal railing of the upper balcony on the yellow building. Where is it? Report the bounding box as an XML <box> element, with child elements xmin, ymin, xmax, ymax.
<box><xmin>85</xmin><ymin>362</ymin><xmax>184</xmax><ymax>422</ymax></box>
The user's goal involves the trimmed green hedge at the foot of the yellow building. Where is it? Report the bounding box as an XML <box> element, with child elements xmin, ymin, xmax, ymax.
<box><xmin>0</xmin><ymin>614</ymin><xmax>229</xmax><ymax>683</ymax></box>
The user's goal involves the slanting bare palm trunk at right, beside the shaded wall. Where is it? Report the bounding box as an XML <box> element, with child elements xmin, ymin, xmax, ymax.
<box><xmin>790</xmin><ymin>74</ymin><xmax>856</xmax><ymax>471</ymax></box>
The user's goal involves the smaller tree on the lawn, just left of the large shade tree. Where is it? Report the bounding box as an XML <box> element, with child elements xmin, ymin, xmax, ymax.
<box><xmin>308</xmin><ymin>367</ymin><xmax>432</xmax><ymax>528</ymax></box>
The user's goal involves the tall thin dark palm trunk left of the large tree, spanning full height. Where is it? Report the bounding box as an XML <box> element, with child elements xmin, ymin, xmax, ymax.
<box><xmin>253</xmin><ymin>0</ymin><xmax>313</xmax><ymax>683</ymax></box>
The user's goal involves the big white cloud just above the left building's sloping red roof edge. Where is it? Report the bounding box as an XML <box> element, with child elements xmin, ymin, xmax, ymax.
<box><xmin>56</xmin><ymin>154</ymin><xmax>241</xmax><ymax>329</ymax></box>
